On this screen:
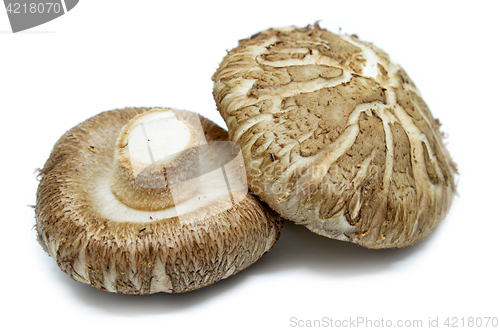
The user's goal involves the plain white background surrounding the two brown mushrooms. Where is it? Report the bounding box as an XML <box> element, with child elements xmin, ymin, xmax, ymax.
<box><xmin>0</xmin><ymin>0</ymin><xmax>500</xmax><ymax>330</ymax></box>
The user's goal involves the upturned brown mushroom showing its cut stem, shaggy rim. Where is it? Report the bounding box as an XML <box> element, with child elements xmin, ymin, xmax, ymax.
<box><xmin>35</xmin><ymin>108</ymin><xmax>282</xmax><ymax>294</ymax></box>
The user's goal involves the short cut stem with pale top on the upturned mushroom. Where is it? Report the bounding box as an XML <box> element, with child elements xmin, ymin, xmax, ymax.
<box><xmin>111</xmin><ymin>108</ymin><xmax>199</xmax><ymax>211</ymax></box>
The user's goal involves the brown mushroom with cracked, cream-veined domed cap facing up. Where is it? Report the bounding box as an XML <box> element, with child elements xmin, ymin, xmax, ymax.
<box><xmin>213</xmin><ymin>25</ymin><xmax>456</xmax><ymax>248</ymax></box>
